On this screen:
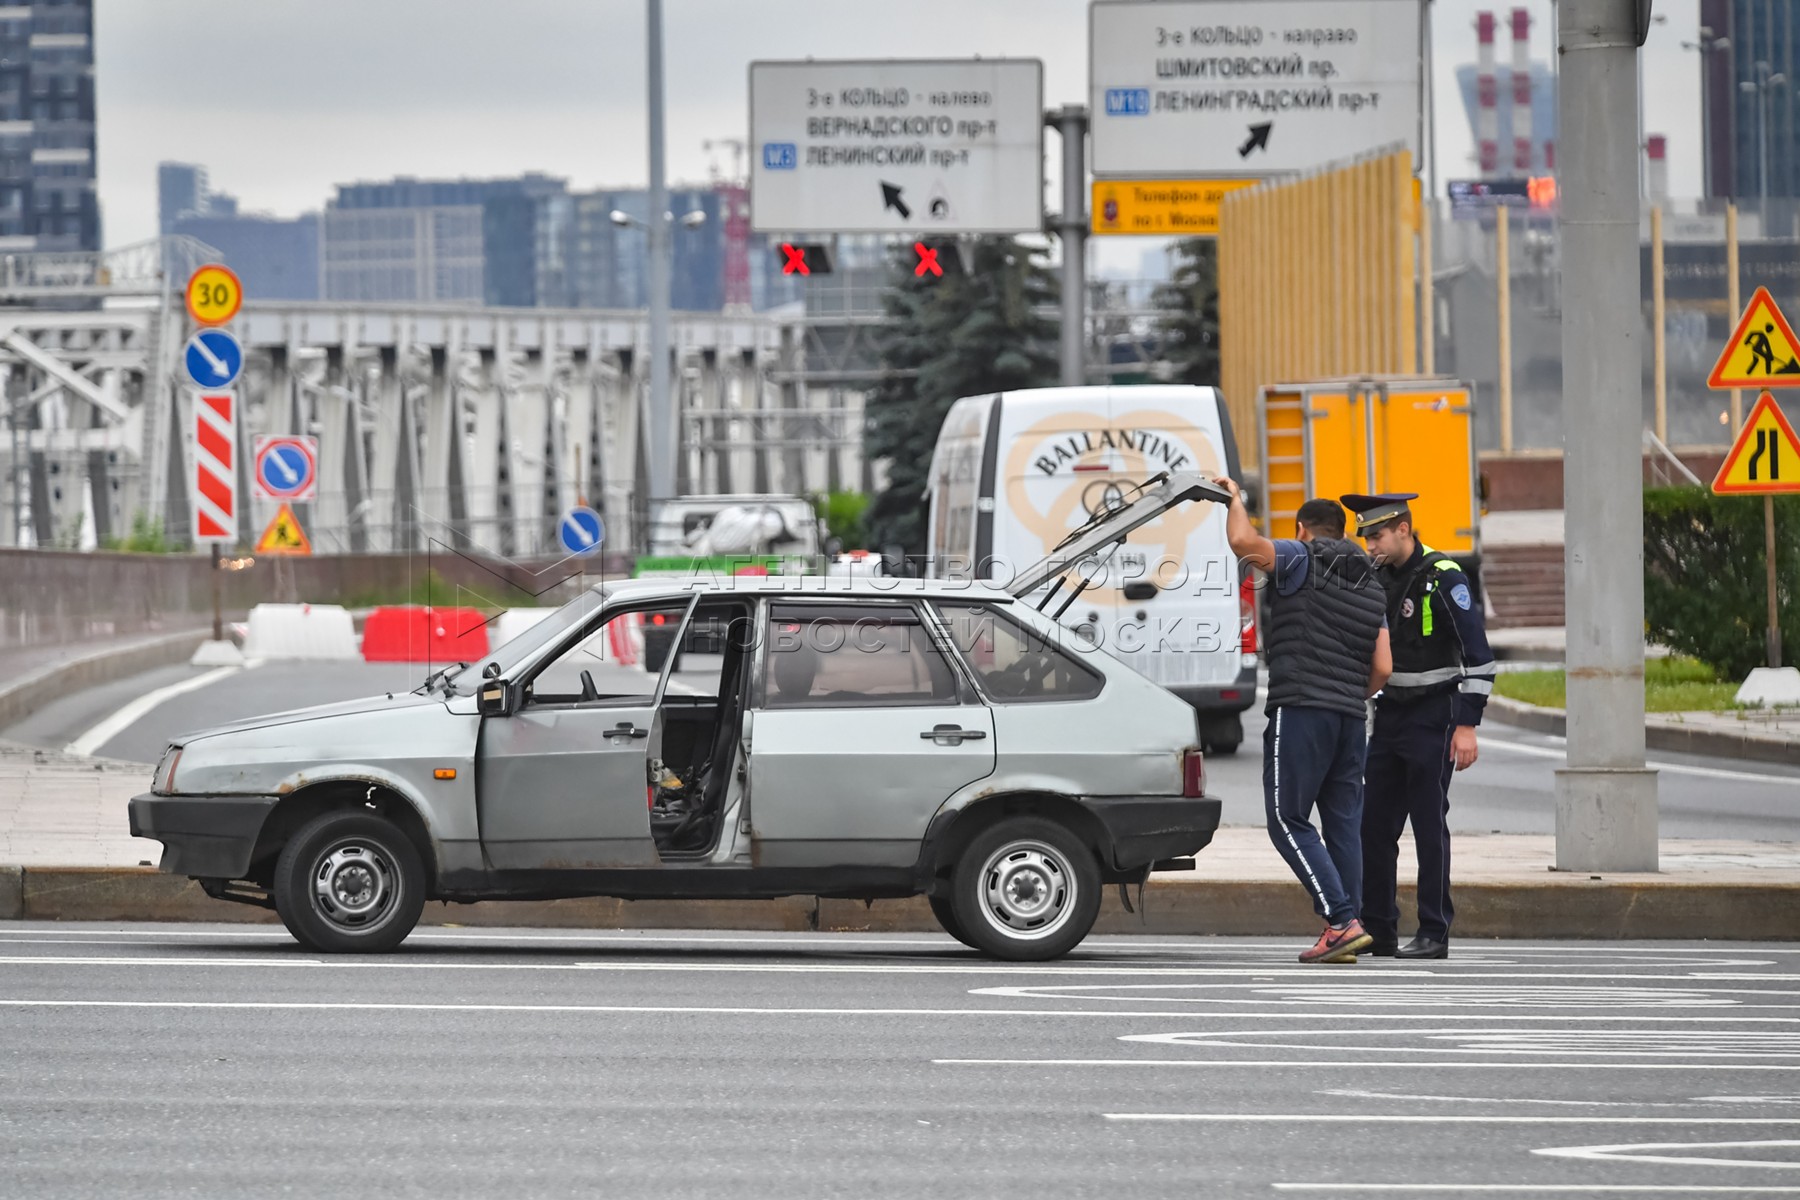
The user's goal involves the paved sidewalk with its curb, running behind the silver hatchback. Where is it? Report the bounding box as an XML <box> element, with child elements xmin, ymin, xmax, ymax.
<box><xmin>0</xmin><ymin>743</ymin><xmax>1800</xmax><ymax>939</ymax></box>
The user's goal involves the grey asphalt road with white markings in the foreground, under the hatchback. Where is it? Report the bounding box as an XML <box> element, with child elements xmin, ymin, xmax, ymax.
<box><xmin>0</xmin><ymin>923</ymin><xmax>1800</xmax><ymax>1200</ymax></box>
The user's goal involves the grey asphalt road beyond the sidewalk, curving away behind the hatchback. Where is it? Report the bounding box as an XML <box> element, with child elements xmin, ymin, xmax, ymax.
<box><xmin>0</xmin><ymin>662</ymin><xmax>1800</xmax><ymax>842</ymax></box>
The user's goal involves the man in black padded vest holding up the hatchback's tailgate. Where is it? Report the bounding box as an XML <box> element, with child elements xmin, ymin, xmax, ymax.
<box><xmin>1219</xmin><ymin>479</ymin><xmax>1391</xmax><ymax>963</ymax></box>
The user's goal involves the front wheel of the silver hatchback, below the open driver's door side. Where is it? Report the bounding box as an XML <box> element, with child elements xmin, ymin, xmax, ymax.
<box><xmin>274</xmin><ymin>811</ymin><xmax>425</xmax><ymax>954</ymax></box>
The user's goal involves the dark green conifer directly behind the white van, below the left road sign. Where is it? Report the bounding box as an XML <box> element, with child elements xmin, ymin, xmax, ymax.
<box><xmin>864</xmin><ymin>237</ymin><xmax>1058</xmax><ymax>554</ymax></box>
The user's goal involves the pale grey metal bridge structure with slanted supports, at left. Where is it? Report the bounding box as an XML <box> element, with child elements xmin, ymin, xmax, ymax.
<box><xmin>0</xmin><ymin>237</ymin><xmax>875</xmax><ymax>556</ymax></box>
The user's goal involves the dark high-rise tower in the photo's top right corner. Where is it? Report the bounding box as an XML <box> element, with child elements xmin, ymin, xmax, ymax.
<box><xmin>1699</xmin><ymin>0</ymin><xmax>1800</xmax><ymax>200</ymax></box>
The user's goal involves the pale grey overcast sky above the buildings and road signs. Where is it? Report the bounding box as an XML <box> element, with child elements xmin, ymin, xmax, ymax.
<box><xmin>94</xmin><ymin>0</ymin><xmax>1699</xmax><ymax>261</ymax></box>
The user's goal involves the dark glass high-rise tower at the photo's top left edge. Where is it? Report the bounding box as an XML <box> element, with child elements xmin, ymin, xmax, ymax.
<box><xmin>0</xmin><ymin>0</ymin><xmax>101</xmax><ymax>252</ymax></box>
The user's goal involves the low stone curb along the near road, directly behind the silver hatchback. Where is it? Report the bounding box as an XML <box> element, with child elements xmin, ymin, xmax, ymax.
<box><xmin>14</xmin><ymin>867</ymin><xmax>1800</xmax><ymax>941</ymax></box>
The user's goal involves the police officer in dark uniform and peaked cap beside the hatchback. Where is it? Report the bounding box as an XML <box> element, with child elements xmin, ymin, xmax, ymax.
<box><xmin>1343</xmin><ymin>491</ymin><xmax>1494</xmax><ymax>959</ymax></box>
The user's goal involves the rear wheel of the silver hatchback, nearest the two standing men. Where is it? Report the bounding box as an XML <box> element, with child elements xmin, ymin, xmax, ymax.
<box><xmin>950</xmin><ymin>817</ymin><xmax>1100</xmax><ymax>963</ymax></box>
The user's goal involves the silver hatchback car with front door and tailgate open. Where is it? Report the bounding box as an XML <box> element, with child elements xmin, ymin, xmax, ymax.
<box><xmin>131</xmin><ymin>479</ymin><xmax>1219</xmax><ymax>959</ymax></box>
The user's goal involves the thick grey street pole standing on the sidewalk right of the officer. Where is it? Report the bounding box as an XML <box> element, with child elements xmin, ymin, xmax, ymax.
<box><xmin>1555</xmin><ymin>0</ymin><xmax>1656</xmax><ymax>871</ymax></box>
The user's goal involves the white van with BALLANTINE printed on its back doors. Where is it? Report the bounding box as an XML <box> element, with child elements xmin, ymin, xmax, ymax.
<box><xmin>927</xmin><ymin>385</ymin><xmax>1256</xmax><ymax>754</ymax></box>
